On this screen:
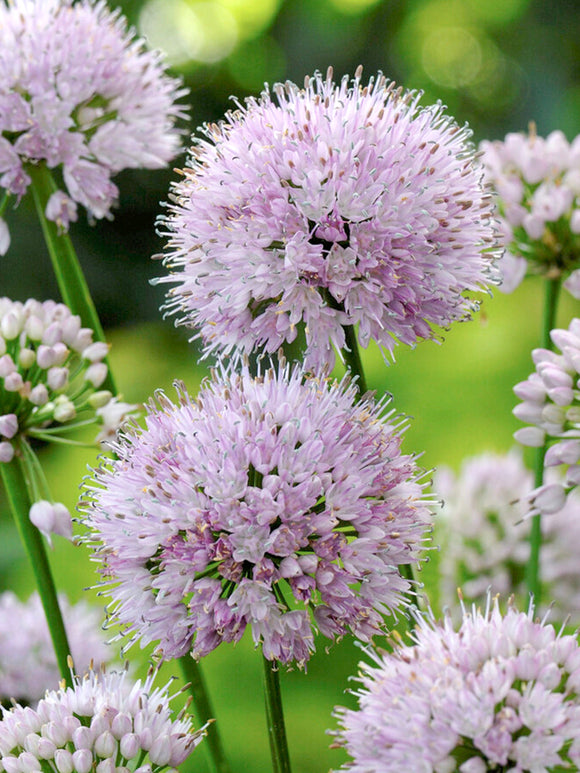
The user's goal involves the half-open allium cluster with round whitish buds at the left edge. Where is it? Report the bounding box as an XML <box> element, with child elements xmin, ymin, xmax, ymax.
<box><xmin>0</xmin><ymin>298</ymin><xmax>136</xmax><ymax>462</ymax></box>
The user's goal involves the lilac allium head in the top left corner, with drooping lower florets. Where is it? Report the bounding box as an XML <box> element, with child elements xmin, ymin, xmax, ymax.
<box><xmin>0</xmin><ymin>0</ymin><xmax>183</xmax><ymax>228</ymax></box>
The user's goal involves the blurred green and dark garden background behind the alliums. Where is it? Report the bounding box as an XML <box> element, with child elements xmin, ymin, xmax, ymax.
<box><xmin>0</xmin><ymin>0</ymin><xmax>580</xmax><ymax>773</ymax></box>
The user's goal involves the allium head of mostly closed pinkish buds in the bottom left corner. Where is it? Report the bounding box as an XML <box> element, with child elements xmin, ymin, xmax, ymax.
<box><xmin>0</xmin><ymin>671</ymin><xmax>204</xmax><ymax>773</ymax></box>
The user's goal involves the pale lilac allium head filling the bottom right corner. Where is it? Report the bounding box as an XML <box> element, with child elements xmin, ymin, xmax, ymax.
<box><xmin>336</xmin><ymin>599</ymin><xmax>580</xmax><ymax>773</ymax></box>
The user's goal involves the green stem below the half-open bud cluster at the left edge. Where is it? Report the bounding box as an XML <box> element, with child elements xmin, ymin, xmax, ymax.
<box><xmin>0</xmin><ymin>456</ymin><xmax>72</xmax><ymax>686</ymax></box>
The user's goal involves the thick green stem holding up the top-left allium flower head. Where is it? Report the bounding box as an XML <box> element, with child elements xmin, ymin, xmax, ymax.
<box><xmin>26</xmin><ymin>164</ymin><xmax>117</xmax><ymax>394</ymax></box>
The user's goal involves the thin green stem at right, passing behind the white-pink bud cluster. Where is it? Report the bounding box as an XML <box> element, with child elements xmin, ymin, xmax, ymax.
<box><xmin>525</xmin><ymin>278</ymin><xmax>560</xmax><ymax>608</ymax></box>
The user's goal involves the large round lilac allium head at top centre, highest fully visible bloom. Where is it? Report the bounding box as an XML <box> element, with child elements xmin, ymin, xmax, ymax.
<box><xmin>159</xmin><ymin>69</ymin><xmax>494</xmax><ymax>368</ymax></box>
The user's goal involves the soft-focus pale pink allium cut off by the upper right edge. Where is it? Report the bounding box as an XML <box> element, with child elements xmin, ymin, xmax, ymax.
<box><xmin>480</xmin><ymin>125</ymin><xmax>580</xmax><ymax>298</ymax></box>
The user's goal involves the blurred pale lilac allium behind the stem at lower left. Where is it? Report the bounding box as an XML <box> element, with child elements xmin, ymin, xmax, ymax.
<box><xmin>0</xmin><ymin>591</ymin><xmax>113</xmax><ymax>705</ymax></box>
